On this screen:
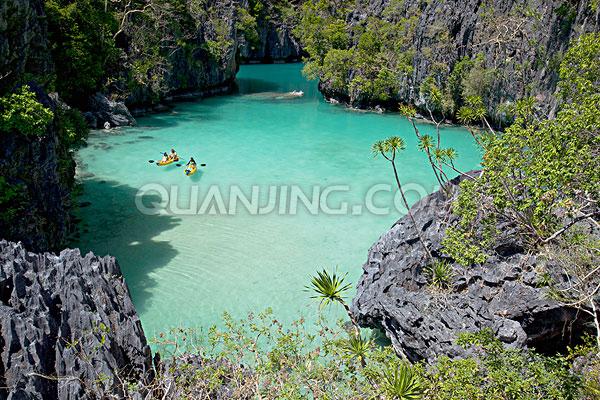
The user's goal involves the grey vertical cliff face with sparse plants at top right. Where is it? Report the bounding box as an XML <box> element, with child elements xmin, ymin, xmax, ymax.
<box><xmin>319</xmin><ymin>0</ymin><xmax>600</xmax><ymax>120</ymax></box>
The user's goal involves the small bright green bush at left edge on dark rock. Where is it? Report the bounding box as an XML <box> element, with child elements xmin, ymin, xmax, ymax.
<box><xmin>0</xmin><ymin>85</ymin><xmax>54</xmax><ymax>136</ymax></box>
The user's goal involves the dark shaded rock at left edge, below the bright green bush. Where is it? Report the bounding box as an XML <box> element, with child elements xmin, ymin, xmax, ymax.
<box><xmin>0</xmin><ymin>85</ymin><xmax>75</xmax><ymax>251</ymax></box>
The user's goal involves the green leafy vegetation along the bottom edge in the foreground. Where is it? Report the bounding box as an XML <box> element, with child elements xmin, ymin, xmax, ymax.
<box><xmin>75</xmin><ymin>271</ymin><xmax>600</xmax><ymax>400</ymax></box>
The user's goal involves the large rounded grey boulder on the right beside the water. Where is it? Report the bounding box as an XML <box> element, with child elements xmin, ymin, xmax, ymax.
<box><xmin>352</xmin><ymin>173</ymin><xmax>584</xmax><ymax>360</ymax></box>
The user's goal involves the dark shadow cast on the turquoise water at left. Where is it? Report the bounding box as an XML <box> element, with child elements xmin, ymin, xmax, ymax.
<box><xmin>71</xmin><ymin>179</ymin><xmax>181</xmax><ymax>313</ymax></box>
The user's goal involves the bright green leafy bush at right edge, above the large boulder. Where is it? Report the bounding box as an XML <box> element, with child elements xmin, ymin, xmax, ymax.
<box><xmin>444</xmin><ymin>34</ymin><xmax>600</xmax><ymax>263</ymax></box>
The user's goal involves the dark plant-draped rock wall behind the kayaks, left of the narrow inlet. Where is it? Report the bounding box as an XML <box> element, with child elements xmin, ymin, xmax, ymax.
<box><xmin>113</xmin><ymin>0</ymin><xmax>239</xmax><ymax>115</ymax></box>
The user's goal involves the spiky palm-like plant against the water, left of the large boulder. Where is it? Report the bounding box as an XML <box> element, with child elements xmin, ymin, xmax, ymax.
<box><xmin>306</xmin><ymin>269</ymin><xmax>360</xmax><ymax>335</ymax></box>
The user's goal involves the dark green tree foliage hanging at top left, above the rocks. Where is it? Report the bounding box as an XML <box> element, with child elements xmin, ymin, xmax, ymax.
<box><xmin>44</xmin><ymin>0</ymin><xmax>118</xmax><ymax>104</ymax></box>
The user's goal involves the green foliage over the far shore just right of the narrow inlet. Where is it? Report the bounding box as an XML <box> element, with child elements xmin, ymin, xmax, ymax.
<box><xmin>295</xmin><ymin>0</ymin><xmax>418</xmax><ymax>103</ymax></box>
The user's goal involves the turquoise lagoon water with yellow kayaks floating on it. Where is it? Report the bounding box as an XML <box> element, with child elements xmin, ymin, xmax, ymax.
<box><xmin>73</xmin><ymin>64</ymin><xmax>480</xmax><ymax>337</ymax></box>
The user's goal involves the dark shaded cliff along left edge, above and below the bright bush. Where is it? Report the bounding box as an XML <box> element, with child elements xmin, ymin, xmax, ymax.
<box><xmin>0</xmin><ymin>0</ymin><xmax>74</xmax><ymax>250</ymax></box>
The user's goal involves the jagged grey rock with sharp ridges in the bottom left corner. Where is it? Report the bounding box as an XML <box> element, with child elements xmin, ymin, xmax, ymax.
<box><xmin>0</xmin><ymin>240</ymin><xmax>152</xmax><ymax>400</ymax></box>
